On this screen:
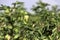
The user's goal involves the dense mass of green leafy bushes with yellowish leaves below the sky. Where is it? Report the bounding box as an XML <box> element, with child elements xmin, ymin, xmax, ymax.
<box><xmin>0</xmin><ymin>1</ymin><xmax>60</xmax><ymax>40</ymax></box>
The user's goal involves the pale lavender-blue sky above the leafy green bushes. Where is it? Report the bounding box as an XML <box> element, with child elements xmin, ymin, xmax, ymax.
<box><xmin>0</xmin><ymin>0</ymin><xmax>60</xmax><ymax>12</ymax></box>
